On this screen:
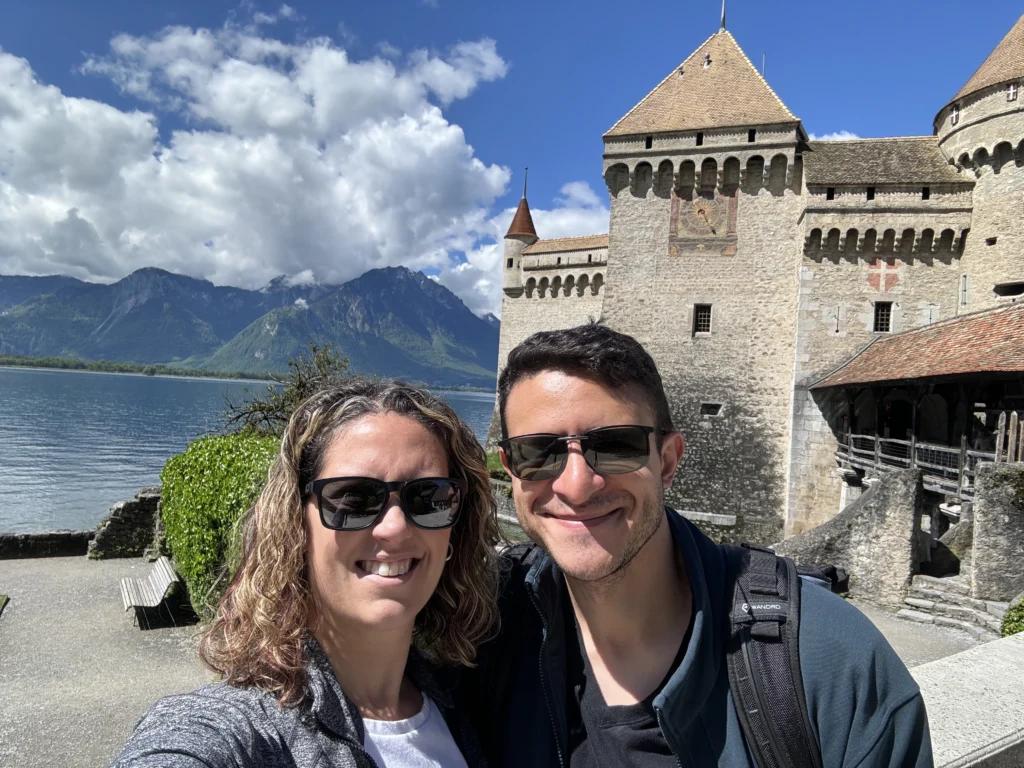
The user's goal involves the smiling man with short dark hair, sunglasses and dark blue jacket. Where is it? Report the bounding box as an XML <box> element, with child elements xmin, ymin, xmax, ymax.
<box><xmin>463</xmin><ymin>324</ymin><xmax>932</xmax><ymax>768</ymax></box>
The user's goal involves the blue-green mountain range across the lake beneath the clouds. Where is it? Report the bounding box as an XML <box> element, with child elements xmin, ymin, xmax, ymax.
<box><xmin>0</xmin><ymin>267</ymin><xmax>499</xmax><ymax>387</ymax></box>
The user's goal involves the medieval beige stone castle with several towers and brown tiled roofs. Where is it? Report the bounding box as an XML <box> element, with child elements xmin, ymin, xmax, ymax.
<box><xmin>488</xmin><ymin>10</ymin><xmax>1024</xmax><ymax>543</ymax></box>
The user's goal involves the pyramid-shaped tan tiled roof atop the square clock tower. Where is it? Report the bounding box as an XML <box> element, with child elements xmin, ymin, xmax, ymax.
<box><xmin>604</xmin><ymin>30</ymin><xmax>797</xmax><ymax>136</ymax></box>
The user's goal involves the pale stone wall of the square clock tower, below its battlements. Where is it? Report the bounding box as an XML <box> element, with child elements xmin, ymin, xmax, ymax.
<box><xmin>604</xmin><ymin>157</ymin><xmax>803</xmax><ymax>544</ymax></box>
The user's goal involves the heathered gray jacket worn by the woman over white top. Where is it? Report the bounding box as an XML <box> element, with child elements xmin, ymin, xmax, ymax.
<box><xmin>112</xmin><ymin>639</ymin><xmax>485</xmax><ymax>768</ymax></box>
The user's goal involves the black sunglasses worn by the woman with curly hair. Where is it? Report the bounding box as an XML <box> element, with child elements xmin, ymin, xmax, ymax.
<box><xmin>304</xmin><ymin>477</ymin><xmax>466</xmax><ymax>530</ymax></box>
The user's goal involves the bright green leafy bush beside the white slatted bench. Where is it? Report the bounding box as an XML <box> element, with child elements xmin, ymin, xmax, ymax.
<box><xmin>160</xmin><ymin>434</ymin><xmax>281</xmax><ymax>618</ymax></box>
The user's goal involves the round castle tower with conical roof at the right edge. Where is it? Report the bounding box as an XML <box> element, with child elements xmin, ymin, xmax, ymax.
<box><xmin>935</xmin><ymin>16</ymin><xmax>1024</xmax><ymax>312</ymax></box>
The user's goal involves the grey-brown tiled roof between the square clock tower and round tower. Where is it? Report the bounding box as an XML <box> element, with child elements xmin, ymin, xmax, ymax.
<box><xmin>804</xmin><ymin>136</ymin><xmax>970</xmax><ymax>184</ymax></box>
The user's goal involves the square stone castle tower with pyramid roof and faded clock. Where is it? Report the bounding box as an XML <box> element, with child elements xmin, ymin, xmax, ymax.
<box><xmin>603</xmin><ymin>27</ymin><xmax>807</xmax><ymax>542</ymax></box>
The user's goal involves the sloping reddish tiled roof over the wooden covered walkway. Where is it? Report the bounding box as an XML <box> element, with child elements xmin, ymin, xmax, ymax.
<box><xmin>811</xmin><ymin>304</ymin><xmax>1024</xmax><ymax>389</ymax></box>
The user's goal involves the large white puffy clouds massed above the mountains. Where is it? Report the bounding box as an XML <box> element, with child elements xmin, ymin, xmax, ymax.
<box><xmin>0</xmin><ymin>5</ymin><xmax>593</xmax><ymax>312</ymax></box>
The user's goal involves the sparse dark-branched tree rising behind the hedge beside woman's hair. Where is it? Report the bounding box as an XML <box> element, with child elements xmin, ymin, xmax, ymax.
<box><xmin>224</xmin><ymin>342</ymin><xmax>349</xmax><ymax>437</ymax></box>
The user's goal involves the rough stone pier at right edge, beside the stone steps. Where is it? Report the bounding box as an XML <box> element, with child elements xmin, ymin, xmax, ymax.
<box><xmin>971</xmin><ymin>463</ymin><xmax>1024</xmax><ymax>600</ymax></box>
